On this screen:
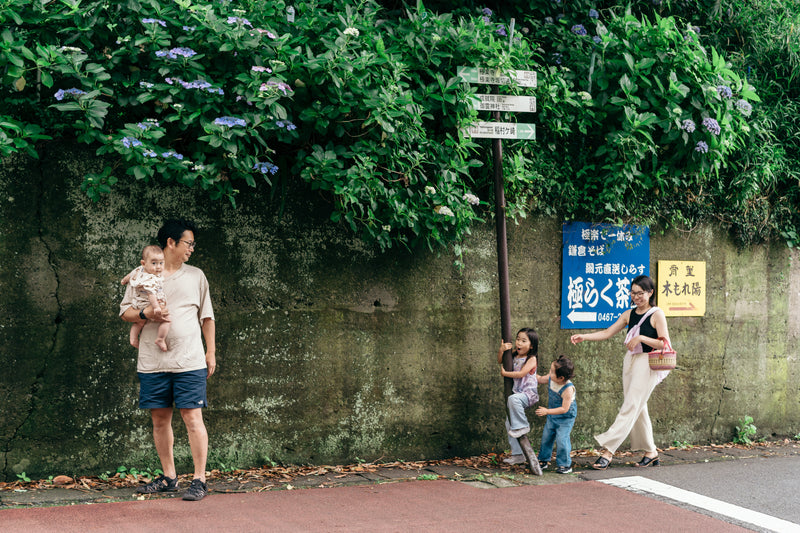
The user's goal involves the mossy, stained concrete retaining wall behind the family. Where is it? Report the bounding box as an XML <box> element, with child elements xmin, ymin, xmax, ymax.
<box><xmin>0</xmin><ymin>145</ymin><xmax>800</xmax><ymax>479</ymax></box>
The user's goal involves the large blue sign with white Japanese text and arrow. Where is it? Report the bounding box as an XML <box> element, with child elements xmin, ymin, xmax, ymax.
<box><xmin>561</xmin><ymin>222</ymin><xmax>650</xmax><ymax>329</ymax></box>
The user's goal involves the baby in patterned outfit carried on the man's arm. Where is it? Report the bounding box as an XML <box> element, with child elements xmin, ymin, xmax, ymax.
<box><xmin>122</xmin><ymin>245</ymin><xmax>170</xmax><ymax>352</ymax></box>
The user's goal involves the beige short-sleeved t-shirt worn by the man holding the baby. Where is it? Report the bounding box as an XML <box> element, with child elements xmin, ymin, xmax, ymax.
<box><xmin>119</xmin><ymin>264</ymin><xmax>214</xmax><ymax>373</ymax></box>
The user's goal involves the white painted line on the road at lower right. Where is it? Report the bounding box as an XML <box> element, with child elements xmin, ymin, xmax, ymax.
<box><xmin>598</xmin><ymin>476</ymin><xmax>800</xmax><ymax>533</ymax></box>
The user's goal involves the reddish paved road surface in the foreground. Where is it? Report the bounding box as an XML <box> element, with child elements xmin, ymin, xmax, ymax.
<box><xmin>0</xmin><ymin>481</ymin><xmax>746</xmax><ymax>533</ymax></box>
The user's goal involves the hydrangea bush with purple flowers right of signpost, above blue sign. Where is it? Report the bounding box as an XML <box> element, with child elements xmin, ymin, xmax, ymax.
<box><xmin>531</xmin><ymin>9</ymin><xmax>760</xmax><ymax>221</ymax></box>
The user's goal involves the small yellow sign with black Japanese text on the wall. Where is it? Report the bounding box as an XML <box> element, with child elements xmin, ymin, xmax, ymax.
<box><xmin>656</xmin><ymin>261</ymin><xmax>706</xmax><ymax>316</ymax></box>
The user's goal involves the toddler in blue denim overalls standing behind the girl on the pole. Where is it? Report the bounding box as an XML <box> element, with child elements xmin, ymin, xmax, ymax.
<box><xmin>536</xmin><ymin>355</ymin><xmax>578</xmax><ymax>474</ymax></box>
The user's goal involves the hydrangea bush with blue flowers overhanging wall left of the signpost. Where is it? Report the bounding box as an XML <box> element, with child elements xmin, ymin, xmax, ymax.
<box><xmin>0</xmin><ymin>0</ymin><xmax>531</xmax><ymax>254</ymax></box>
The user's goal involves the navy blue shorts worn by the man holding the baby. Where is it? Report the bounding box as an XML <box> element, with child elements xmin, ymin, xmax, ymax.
<box><xmin>138</xmin><ymin>368</ymin><xmax>208</xmax><ymax>409</ymax></box>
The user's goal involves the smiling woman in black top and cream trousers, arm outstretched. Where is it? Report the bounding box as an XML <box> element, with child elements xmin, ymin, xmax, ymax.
<box><xmin>570</xmin><ymin>276</ymin><xmax>674</xmax><ymax>470</ymax></box>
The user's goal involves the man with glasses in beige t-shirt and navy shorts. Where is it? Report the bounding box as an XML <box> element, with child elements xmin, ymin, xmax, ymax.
<box><xmin>120</xmin><ymin>220</ymin><xmax>216</xmax><ymax>501</ymax></box>
